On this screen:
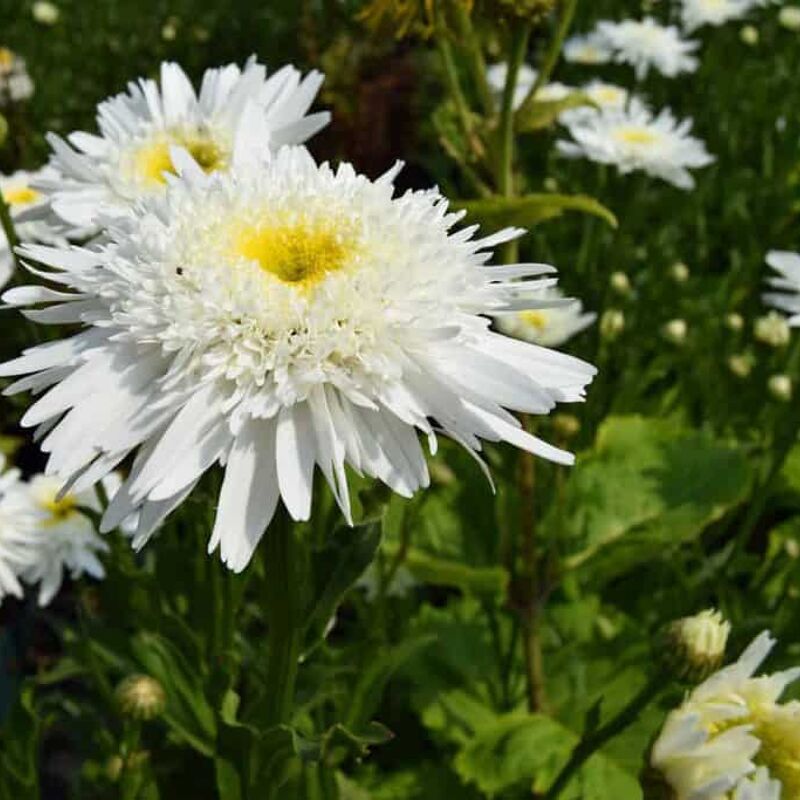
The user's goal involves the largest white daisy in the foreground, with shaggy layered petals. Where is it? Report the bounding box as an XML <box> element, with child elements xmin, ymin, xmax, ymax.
<box><xmin>0</xmin><ymin>148</ymin><xmax>595</xmax><ymax>570</ymax></box>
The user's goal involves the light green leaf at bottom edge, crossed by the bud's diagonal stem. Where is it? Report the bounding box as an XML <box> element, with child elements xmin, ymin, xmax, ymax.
<box><xmin>455</xmin><ymin>712</ymin><xmax>641</xmax><ymax>800</ymax></box>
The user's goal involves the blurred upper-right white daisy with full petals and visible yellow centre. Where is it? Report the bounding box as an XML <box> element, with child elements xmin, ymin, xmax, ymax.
<box><xmin>557</xmin><ymin>98</ymin><xmax>714</xmax><ymax>189</ymax></box>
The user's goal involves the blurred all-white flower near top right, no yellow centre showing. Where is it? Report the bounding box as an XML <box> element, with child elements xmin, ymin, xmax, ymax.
<box><xmin>597</xmin><ymin>17</ymin><xmax>700</xmax><ymax>80</ymax></box>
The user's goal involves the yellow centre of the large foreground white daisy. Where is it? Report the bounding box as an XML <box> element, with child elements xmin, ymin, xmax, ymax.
<box><xmin>233</xmin><ymin>221</ymin><xmax>355</xmax><ymax>288</ymax></box>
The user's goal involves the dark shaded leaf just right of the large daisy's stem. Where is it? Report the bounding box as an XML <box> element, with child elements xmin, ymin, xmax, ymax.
<box><xmin>306</xmin><ymin>523</ymin><xmax>381</xmax><ymax>647</ymax></box>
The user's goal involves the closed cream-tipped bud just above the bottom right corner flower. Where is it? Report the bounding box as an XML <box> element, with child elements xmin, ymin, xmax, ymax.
<box><xmin>662</xmin><ymin>608</ymin><xmax>731</xmax><ymax>683</ymax></box>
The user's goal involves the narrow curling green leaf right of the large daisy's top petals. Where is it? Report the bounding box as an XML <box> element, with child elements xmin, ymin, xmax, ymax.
<box><xmin>454</xmin><ymin>193</ymin><xmax>617</xmax><ymax>232</ymax></box>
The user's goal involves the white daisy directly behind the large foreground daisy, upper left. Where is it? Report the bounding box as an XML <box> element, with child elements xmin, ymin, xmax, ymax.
<box><xmin>39</xmin><ymin>59</ymin><xmax>330</xmax><ymax>226</ymax></box>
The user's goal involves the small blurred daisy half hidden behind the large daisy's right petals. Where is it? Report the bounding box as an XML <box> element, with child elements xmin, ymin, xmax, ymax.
<box><xmin>495</xmin><ymin>289</ymin><xmax>597</xmax><ymax>347</ymax></box>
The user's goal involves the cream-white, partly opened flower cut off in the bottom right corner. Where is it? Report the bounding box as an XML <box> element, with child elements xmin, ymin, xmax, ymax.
<box><xmin>651</xmin><ymin>632</ymin><xmax>800</xmax><ymax>800</ymax></box>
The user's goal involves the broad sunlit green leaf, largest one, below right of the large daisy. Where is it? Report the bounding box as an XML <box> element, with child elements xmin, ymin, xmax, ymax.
<box><xmin>545</xmin><ymin>416</ymin><xmax>751</xmax><ymax>585</ymax></box>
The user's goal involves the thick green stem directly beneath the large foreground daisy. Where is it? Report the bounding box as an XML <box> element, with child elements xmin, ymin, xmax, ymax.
<box><xmin>261</xmin><ymin>514</ymin><xmax>303</xmax><ymax>727</ymax></box>
